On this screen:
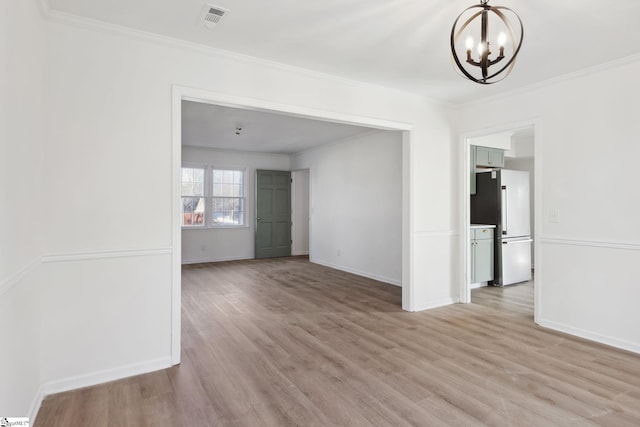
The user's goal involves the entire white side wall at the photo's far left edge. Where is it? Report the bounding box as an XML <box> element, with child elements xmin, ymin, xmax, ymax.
<box><xmin>0</xmin><ymin>0</ymin><xmax>46</xmax><ymax>416</ymax></box>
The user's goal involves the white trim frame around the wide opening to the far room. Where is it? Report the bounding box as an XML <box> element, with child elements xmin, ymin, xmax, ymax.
<box><xmin>171</xmin><ymin>85</ymin><xmax>415</xmax><ymax>365</ymax></box>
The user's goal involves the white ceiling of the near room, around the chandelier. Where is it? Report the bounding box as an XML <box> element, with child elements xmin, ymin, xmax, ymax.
<box><xmin>45</xmin><ymin>0</ymin><xmax>640</xmax><ymax>103</ymax></box>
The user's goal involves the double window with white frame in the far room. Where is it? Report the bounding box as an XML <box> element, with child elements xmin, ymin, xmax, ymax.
<box><xmin>181</xmin><ymin>166</ymin><xmax>245</xmax><ymax>227</ymax></box>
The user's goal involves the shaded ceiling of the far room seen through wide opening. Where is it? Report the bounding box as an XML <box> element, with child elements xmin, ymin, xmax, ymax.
<box><xmin>182</xmin><ymin>101</ymin><xmax>372</xmax><ymax>154</ymax></box>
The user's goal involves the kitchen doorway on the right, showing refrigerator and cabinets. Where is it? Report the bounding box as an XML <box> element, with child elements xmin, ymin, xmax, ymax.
<box><xmin>460</xmin><ymin>122</ymin><xmax>542</xmax><ymax>321</ymax></box>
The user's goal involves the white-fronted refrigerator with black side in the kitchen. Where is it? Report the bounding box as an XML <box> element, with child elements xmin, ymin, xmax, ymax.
<box><xmin>471</xmin><ymin>169</ymin><xmax>533</xmax><ymax>286</ymax></box>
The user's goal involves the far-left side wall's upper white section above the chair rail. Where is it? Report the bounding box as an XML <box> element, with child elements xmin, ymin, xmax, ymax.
<box><xmin>0</xmin><ymin>0</ymin><xmax>44</xmax><ymax>278</ymax></box>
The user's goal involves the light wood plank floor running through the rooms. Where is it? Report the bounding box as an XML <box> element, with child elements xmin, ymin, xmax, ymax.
<box><xmin>35</xmin><ymin>257</ymin><xmax>640</xmax><ymax>427</ymax></box>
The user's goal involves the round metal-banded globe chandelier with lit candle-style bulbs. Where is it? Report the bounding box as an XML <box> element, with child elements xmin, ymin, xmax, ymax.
<box><xmin>451</xmin><ymin>0</ymin><xmax>524</xmax><ymax>84</ymax></box>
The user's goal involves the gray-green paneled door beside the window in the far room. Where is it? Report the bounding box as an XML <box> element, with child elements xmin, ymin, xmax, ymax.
<box><xmin>256</xmin><ymin>170</ymin><xmax>291</xmax><ymax>258</ymax></box>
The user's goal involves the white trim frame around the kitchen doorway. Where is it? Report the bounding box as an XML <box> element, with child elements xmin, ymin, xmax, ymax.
<box><xmin>459</xmin><ymin>119</ymin><xmax>544</xmax><ymax>323</ymax></box>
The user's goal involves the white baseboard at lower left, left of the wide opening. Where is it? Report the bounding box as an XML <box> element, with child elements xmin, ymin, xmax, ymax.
<box><xmin>29</xmin><ymin>357</ymin><xmax>171</xmax><ymax>424</ymax></box>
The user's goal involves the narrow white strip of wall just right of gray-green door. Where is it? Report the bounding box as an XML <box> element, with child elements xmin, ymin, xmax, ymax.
<box><xmin>291</xmin><ymin>169</ymin><xmax>310</xmax><ymax>255</ymax></box>
